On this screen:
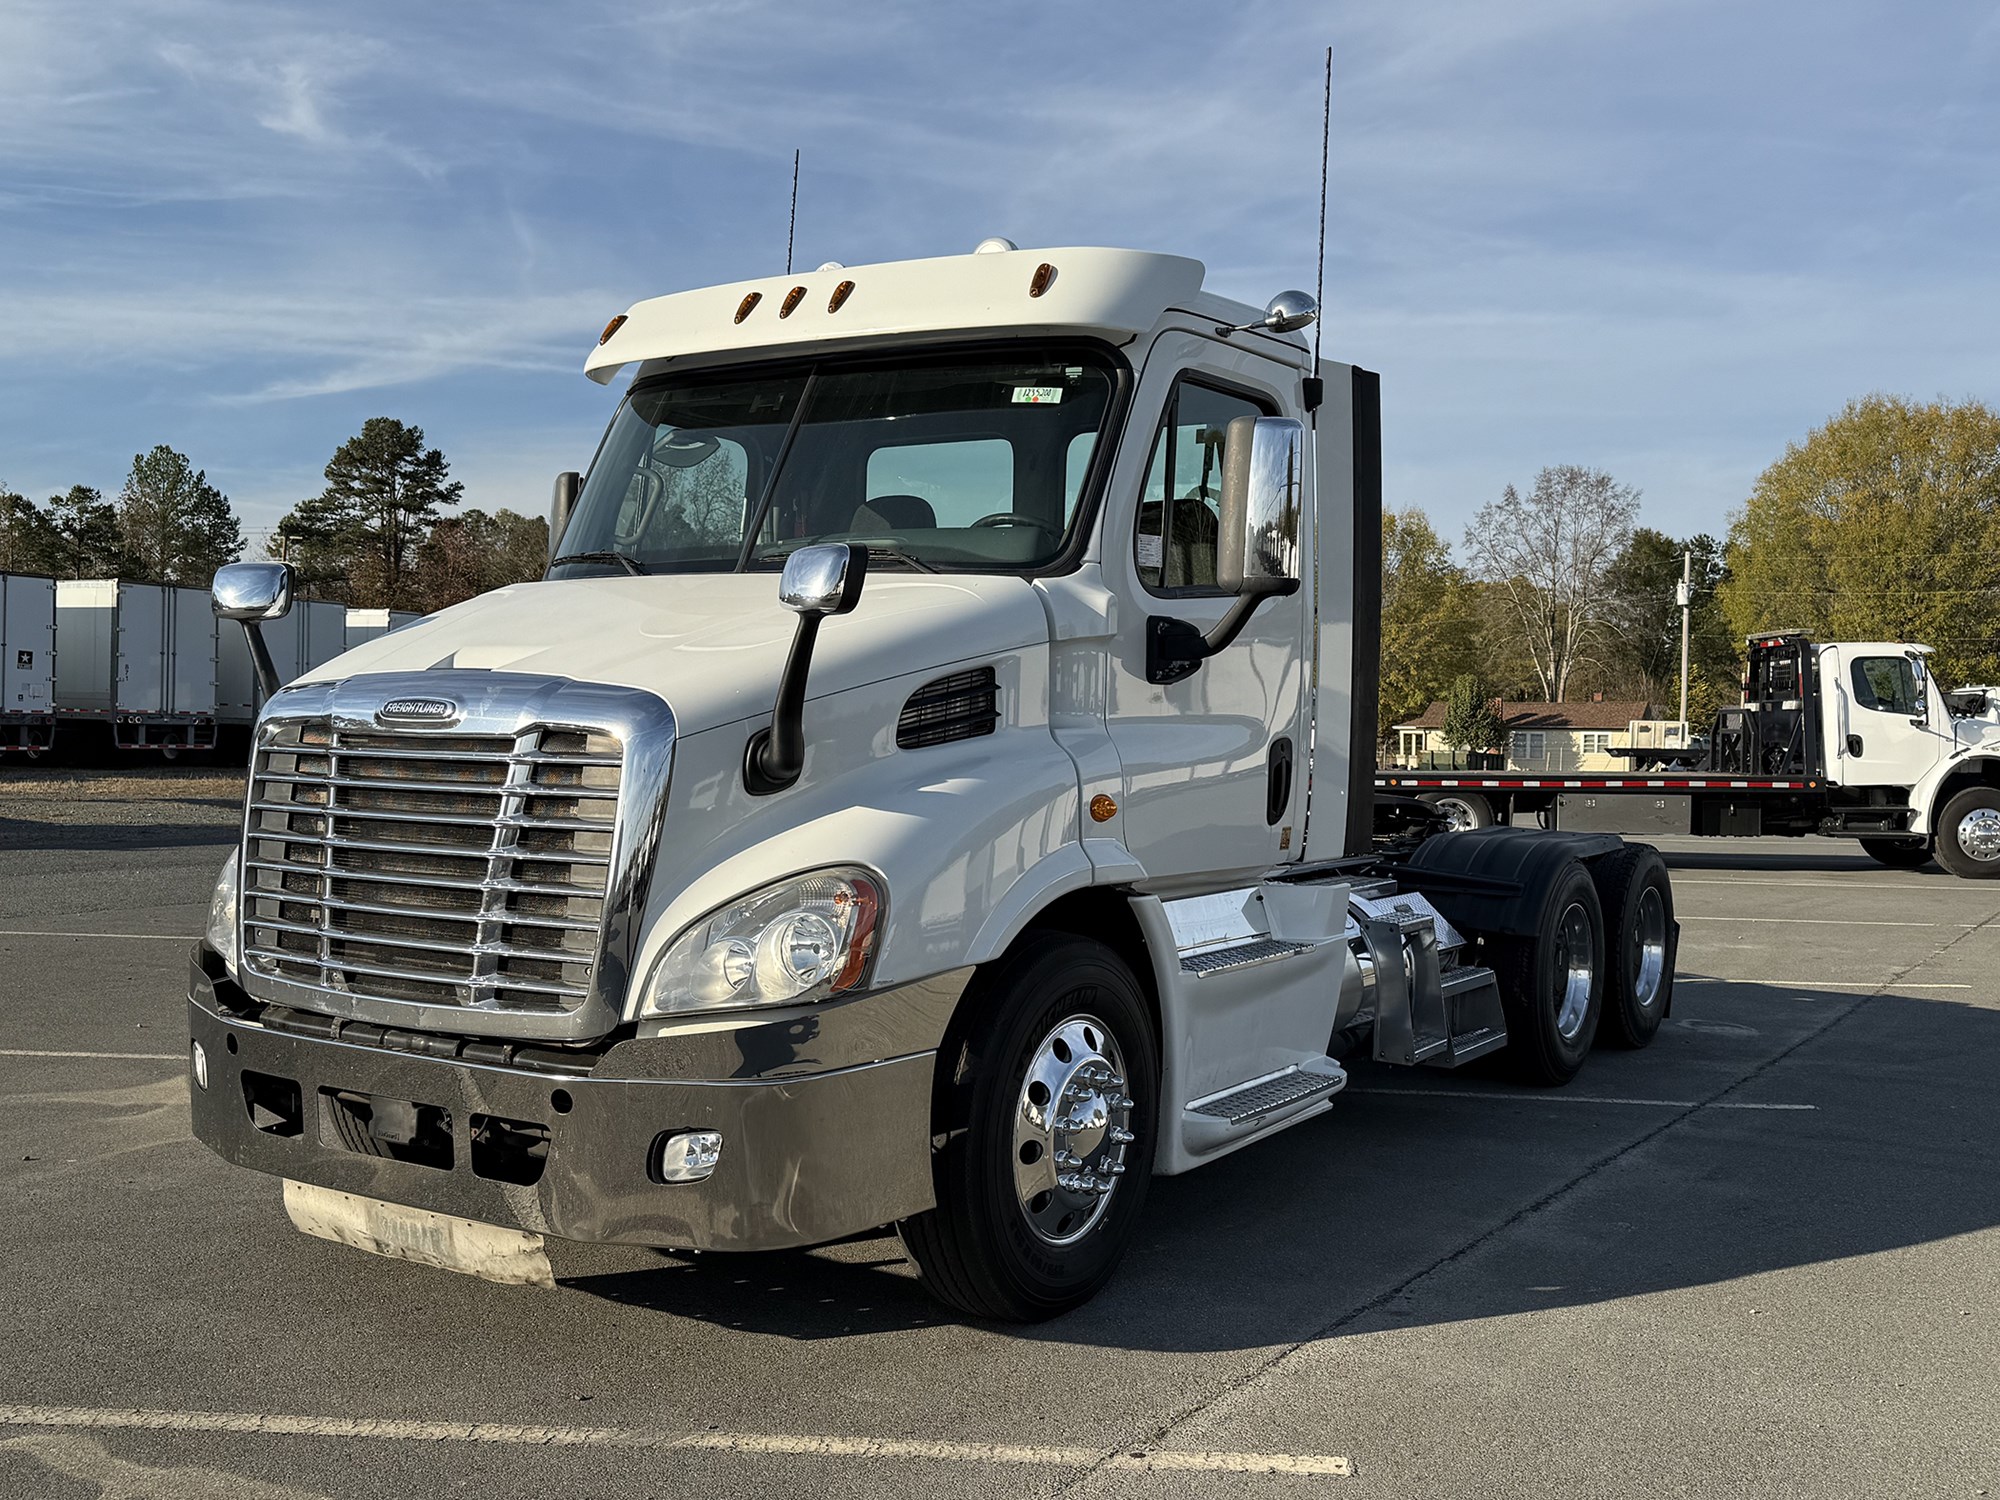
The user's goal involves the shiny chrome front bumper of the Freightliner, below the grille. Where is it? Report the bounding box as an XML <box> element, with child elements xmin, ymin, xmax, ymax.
<box><xmin>188</xmin><ymin>950</ymin><xmax>964</xmax><ymax>1250</ymax></box>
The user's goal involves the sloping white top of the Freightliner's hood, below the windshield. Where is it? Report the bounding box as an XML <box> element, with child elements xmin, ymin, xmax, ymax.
<box><xmin>302</xmin><ymin>572</ymin><xmax>1048</xmax><ymax>734</ymax></box>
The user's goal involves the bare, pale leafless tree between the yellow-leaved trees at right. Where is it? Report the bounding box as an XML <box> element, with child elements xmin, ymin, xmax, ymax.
<box><xmin>1466</xmin><ymin>464</ymin><xmax>1638</xmax><ymax>702</ymax></box>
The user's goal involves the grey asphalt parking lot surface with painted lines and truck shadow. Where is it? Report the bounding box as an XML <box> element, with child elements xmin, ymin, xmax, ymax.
<box><xmin>0</xmin><ymin>772</ymin><xmax>2000</xmax><ymax>1500</ymax></box>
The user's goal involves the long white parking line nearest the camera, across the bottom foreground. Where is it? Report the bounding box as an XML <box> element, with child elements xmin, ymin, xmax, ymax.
<box><xmin>0</xmin><ymin>1404</ymin><xmax>1354</xmax><ymax>1478</ymax></box>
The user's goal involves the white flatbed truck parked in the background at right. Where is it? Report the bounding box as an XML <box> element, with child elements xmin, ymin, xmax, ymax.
<box><xmin>1376</xmin><ymin>630</ymin><xmax>2000</xmax><ymax>880</ymax></box>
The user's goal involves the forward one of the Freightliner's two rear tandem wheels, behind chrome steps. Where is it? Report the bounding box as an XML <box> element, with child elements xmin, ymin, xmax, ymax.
<box><xmin>1488</xmin><ymin>860</ymin><xmax>1604</xmax><ymax>1088</ymax></box>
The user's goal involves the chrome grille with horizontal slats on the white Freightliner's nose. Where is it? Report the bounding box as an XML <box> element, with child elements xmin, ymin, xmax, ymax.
<box><xmin>242</xmin><ymin>716</ymin><xmax>624</xmax><ymax>1014</ymax></box>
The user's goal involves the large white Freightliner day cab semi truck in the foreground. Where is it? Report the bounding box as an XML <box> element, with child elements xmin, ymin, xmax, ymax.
<box><xmin>188</xmin><ymin>242</ymin><xmax>1678</xmax><ymax>1320</ymax></box>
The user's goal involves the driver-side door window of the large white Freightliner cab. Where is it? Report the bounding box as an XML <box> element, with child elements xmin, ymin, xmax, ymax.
<box><xmin>1132</xmin><ymin>378</ymin><xmax>1270</xmax><ymax>594</ymax></box>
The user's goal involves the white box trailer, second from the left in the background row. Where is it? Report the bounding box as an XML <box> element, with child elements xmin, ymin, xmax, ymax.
<box><xmin>56</xmin><ymin>578</ymin><xmax>218</xmax><ymax>756</ymax></box>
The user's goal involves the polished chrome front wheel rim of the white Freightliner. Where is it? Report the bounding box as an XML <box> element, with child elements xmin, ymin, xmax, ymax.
<box><xmin>1014</xmin><ymin>1016</ymin><xmax>1134</xmax><ymax>1244</ymax></box>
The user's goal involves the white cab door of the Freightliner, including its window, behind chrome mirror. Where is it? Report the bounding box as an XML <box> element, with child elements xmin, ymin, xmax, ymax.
<box><xmin>1100</xmin><ymin>332</ymin><xmax>1312</xmax><ymax>888</ymax></box>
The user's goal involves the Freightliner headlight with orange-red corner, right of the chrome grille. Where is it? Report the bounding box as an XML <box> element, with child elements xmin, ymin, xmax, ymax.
<box><xmin>640</xmin><ymin>870</ymin><xmax>882</xmax><ymax>1016</ymax></box>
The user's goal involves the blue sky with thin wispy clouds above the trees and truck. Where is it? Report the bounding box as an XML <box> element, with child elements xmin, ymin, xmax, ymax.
<box><xmin>0</xmin><ymin>0</ymin><xmax>2000</xmax><ymax>556</ymax></box>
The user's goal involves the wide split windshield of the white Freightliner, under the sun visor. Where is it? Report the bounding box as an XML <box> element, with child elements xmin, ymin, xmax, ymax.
<box><xmin>550</xmin><ymin>348</ymin><xmax>1116</xmax><ymax>578</ymax></box>
